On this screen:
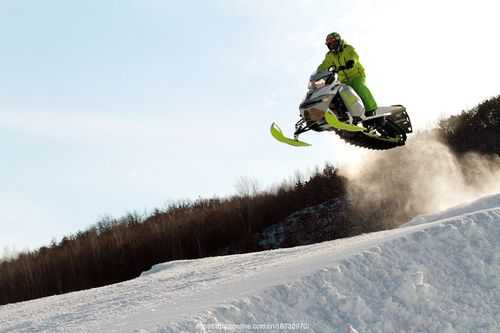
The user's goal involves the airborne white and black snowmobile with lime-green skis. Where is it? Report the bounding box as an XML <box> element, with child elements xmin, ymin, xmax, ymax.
<box><xmin>271</xmin><ymin>69</ymin><xmax>413</xmax><ymax>150</ymax></box>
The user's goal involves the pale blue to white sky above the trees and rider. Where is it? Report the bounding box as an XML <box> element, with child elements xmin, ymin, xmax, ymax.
<box><xmin>0</xmin><ymin>0</ymin><xmax>500</xmax><ymax>251</ymax></box>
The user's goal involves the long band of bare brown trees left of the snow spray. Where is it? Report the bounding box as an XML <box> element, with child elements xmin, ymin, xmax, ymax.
<box><xmin>0</xmin><ymin>165</ymin><xmax>346</xmax><ymax>304</ymax></box>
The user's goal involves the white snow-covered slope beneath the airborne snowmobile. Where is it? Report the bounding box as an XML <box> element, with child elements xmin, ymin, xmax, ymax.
<box><xmin>0</xmin><ymin>195</ymin><xmax>500</xmax><ymax>333</ymax></box>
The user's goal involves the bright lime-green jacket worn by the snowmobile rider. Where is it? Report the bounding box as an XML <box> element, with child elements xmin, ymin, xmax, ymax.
<box><xmin>318</xmin><ymin>43</ymin><xmax>365</xmax><ymax>83</ymax></box>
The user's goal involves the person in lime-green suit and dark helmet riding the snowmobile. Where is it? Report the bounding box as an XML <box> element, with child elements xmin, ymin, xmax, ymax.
<box><xmin>318</xmin><ymin>32</ymin><xmax>377</xmax><ymax>116</ymax></box>
